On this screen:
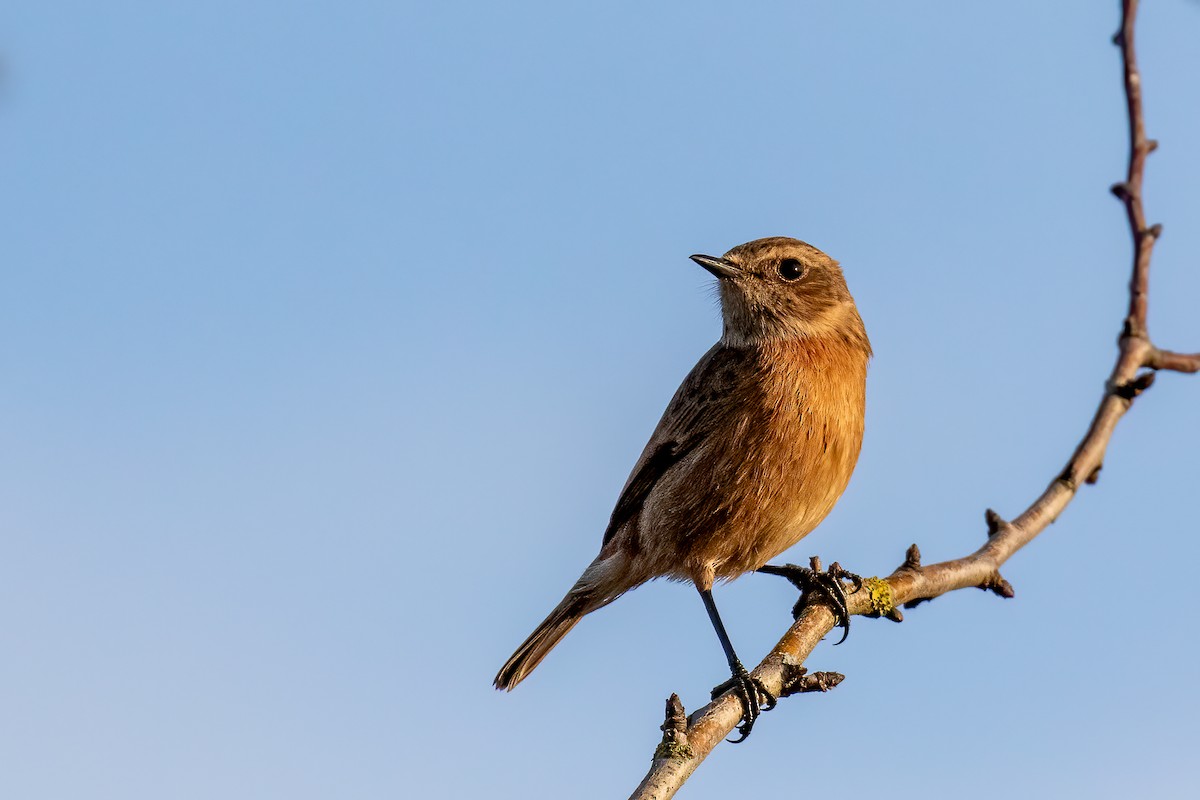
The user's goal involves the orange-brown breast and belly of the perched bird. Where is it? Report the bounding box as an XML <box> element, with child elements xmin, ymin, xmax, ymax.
<box><xmin>656</xmin><ymin>342</ymin><xmax>866</xmax><ymax>581</ymax></box>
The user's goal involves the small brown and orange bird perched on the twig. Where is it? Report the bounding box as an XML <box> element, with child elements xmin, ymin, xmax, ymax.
<box><xmin>493</xmin><ymin>236</ymin><xmax>872</xmax><ymax>741</ymax></box>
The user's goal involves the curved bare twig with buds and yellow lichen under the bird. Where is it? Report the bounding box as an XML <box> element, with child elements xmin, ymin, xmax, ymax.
<box><xmin>631</xmin><ymin>0</ymin><xmax>1200</xmax><ymax>800</ymax></box>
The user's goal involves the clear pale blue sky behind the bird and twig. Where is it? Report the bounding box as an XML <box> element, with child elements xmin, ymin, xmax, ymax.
<box><xmin>0</xmin><ymin>0</ymin><xmax>1200</xmax><ymax>800</ymax></box>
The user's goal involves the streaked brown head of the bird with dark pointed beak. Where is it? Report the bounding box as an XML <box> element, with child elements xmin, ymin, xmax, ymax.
<box><xmin>691</xmin><ymin>236</ymin><xmax>870</xmax><ymax>353</ymax></box>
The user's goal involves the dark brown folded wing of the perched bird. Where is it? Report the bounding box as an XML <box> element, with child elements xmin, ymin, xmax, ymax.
<box><xmin>604</xmin><ymin>344</ymin><xmax>745</xmax><ymax>545</ymax></box>
